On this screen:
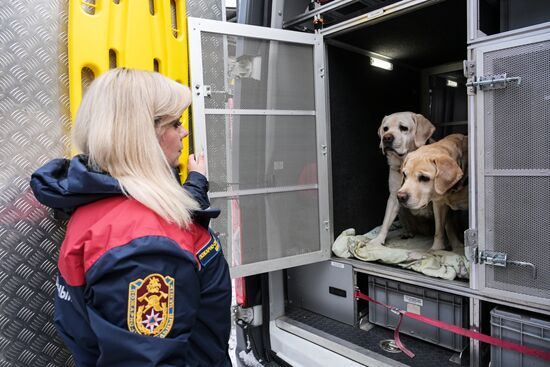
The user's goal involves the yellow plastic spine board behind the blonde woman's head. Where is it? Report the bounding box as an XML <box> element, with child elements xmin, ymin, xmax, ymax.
<box><xmin>68</xmin><ymin>0</ymin><xmax>189</xmax><ymax>182</ymax></box>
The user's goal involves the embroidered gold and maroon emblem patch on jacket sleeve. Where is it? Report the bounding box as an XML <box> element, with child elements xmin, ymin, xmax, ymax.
<box><xmin>128</xmin><ymin>274</ymin><xmax>175</xmax><ymax>338</ymax></box>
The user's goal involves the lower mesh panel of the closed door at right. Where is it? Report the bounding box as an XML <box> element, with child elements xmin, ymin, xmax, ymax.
<box><xmin>485</xmin><ymin>177</ymin><xmax>550</xmax><ymax>299</ymax></box>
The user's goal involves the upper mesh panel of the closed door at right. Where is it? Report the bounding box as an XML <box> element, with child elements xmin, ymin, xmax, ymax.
<box><xmin>484</xmin><ymin>41</ymin><xmax>550</xmax><ymax>170</ymax></box>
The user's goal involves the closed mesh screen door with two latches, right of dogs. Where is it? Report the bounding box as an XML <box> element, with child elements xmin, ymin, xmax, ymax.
<box><xmin>475</xmin><ymin>32</ymin><xmax>550</xmax><ymax>305</ymax></box>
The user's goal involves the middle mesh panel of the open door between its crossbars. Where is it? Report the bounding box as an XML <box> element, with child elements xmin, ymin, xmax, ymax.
<box><xmin>206</xmin><ymin>115</ymin><xmax>318</xmax><ymax>193</ymax></box>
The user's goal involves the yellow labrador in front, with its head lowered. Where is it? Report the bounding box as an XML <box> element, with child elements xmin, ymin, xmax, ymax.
<box><xmin>397</xmin><ymin>134</ymin><xmax>468</xmax><ymax>250</ymax></box>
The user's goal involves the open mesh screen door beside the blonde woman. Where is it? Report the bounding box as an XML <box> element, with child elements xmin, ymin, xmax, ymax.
<box><xmin>188</xmin><ymin>18</ymin><xmax>330</xmax><ymax>277</ymax></box>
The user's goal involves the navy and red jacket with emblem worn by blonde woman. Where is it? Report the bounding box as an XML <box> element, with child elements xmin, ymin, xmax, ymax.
<box><xmin>31</xmin><ymin>156</ymin><xmax>231</xmax><ymax>367</ymax></box>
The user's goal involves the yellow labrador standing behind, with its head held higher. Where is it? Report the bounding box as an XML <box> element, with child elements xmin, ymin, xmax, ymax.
<box><xmin>370</xmin><ymin>112</ymin><xmax>435</xmax><ymax>245</ymax></box>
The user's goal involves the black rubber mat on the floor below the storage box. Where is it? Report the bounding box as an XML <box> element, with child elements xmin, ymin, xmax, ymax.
<box><xmin>286</xmin><ymin>307</ymin><xmax>469</xmax><ymax>367</ymax></box>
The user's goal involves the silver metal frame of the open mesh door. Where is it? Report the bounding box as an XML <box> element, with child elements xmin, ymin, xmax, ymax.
<box><xmin>187</xmin><ymin>17</ymin><xmax>332</xmax><ymax>278</ymax></box>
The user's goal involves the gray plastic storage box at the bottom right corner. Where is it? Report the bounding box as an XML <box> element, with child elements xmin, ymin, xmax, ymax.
<box><xmin>491</xmin><ymin>307</ymin><xmax>550</xmax><ymax>367</ymax></box>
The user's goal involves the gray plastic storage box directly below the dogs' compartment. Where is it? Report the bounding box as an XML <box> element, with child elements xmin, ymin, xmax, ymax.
<box><xmin>368</xmin><ymin>276</ymin><xmax>469</xmax><ymax>352</ymax></box>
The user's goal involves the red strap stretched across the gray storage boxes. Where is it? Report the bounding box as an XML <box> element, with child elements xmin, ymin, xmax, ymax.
<box><xmin>355</xmin><ymin>291</ymin><xmax>550</xmax><ymax>361</ymax></box>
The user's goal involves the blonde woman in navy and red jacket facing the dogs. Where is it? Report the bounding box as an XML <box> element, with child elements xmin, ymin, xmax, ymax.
<box><xmin>31</xmin><ymin>69</ymin><xmax>231</xmax><ymax>367</ymax></box>
